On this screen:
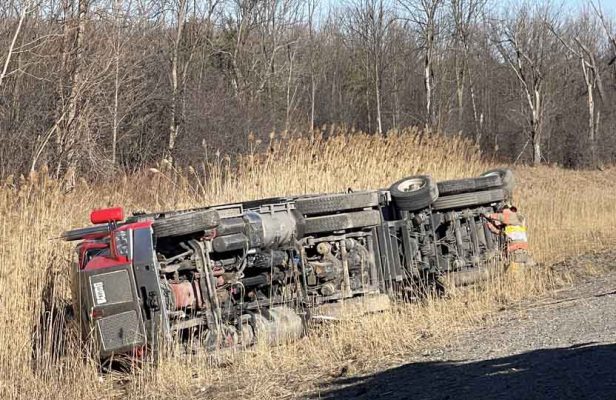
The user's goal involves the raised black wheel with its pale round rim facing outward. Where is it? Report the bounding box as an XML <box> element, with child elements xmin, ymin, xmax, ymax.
<box><xmin>389</xmin><ymin>175</ymin><xmax>439</xmax><ymax>211</ymax></box>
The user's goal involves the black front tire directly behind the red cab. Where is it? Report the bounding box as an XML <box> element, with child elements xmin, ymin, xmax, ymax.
<box><xmin>152</xmin><ymin>210</ymin><xmax>220</xmax><ymax>238</ymax></box>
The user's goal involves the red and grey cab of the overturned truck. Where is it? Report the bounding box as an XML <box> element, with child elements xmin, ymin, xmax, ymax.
<box><xmin>65</xmin><ymin>208</ymin><xmax>163</xmax><ymax>358</ymax></box>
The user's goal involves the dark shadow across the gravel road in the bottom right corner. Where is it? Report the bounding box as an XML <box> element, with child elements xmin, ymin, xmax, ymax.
<box><xmin>314</xmin><ymin>343</ymin><xmax>616</xmax><ymax>400</ymax></box>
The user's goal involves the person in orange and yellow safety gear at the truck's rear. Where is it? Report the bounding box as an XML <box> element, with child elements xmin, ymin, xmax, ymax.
<box><xmin>487</xmin><ymin>204</ymin><xmax>534</xmax><ymax>269</ymax></box>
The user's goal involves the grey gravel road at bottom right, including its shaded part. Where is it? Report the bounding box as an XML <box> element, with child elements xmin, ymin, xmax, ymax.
<box><xmin>316</xmin><ymin>268</ymin><xmax>616</xmax><ymax>400</ymax></box>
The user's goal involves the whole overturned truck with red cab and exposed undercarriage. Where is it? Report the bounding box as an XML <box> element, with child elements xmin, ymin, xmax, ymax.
<box><xmin>62</xmin><ymin>169</ymin><xmax>514</xmax><ymax>359</ymax></box>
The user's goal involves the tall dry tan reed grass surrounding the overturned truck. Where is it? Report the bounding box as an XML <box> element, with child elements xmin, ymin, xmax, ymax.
<box><xmin>0</xmin><ymin>127</ymin><xmax>616</xmax><ymax>400</ymax></box>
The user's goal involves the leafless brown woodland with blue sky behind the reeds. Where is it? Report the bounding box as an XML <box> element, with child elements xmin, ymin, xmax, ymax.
<box><xmin>0</xmin><ymin>0</ymin><xmax>616</xmax><ymax>177</ymax></box>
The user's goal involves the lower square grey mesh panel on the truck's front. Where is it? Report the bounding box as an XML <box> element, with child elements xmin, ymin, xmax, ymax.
<box><xmin>96</xmin><ymin>310</ymin><xmax>143</xmax><ymax>352</ymax></box>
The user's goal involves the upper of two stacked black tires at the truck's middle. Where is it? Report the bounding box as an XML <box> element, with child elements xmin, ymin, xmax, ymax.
<box><xmin>295</xmin><ymin>192</ymin><xmax>379</xmax><ymax>215</ymax></box>
